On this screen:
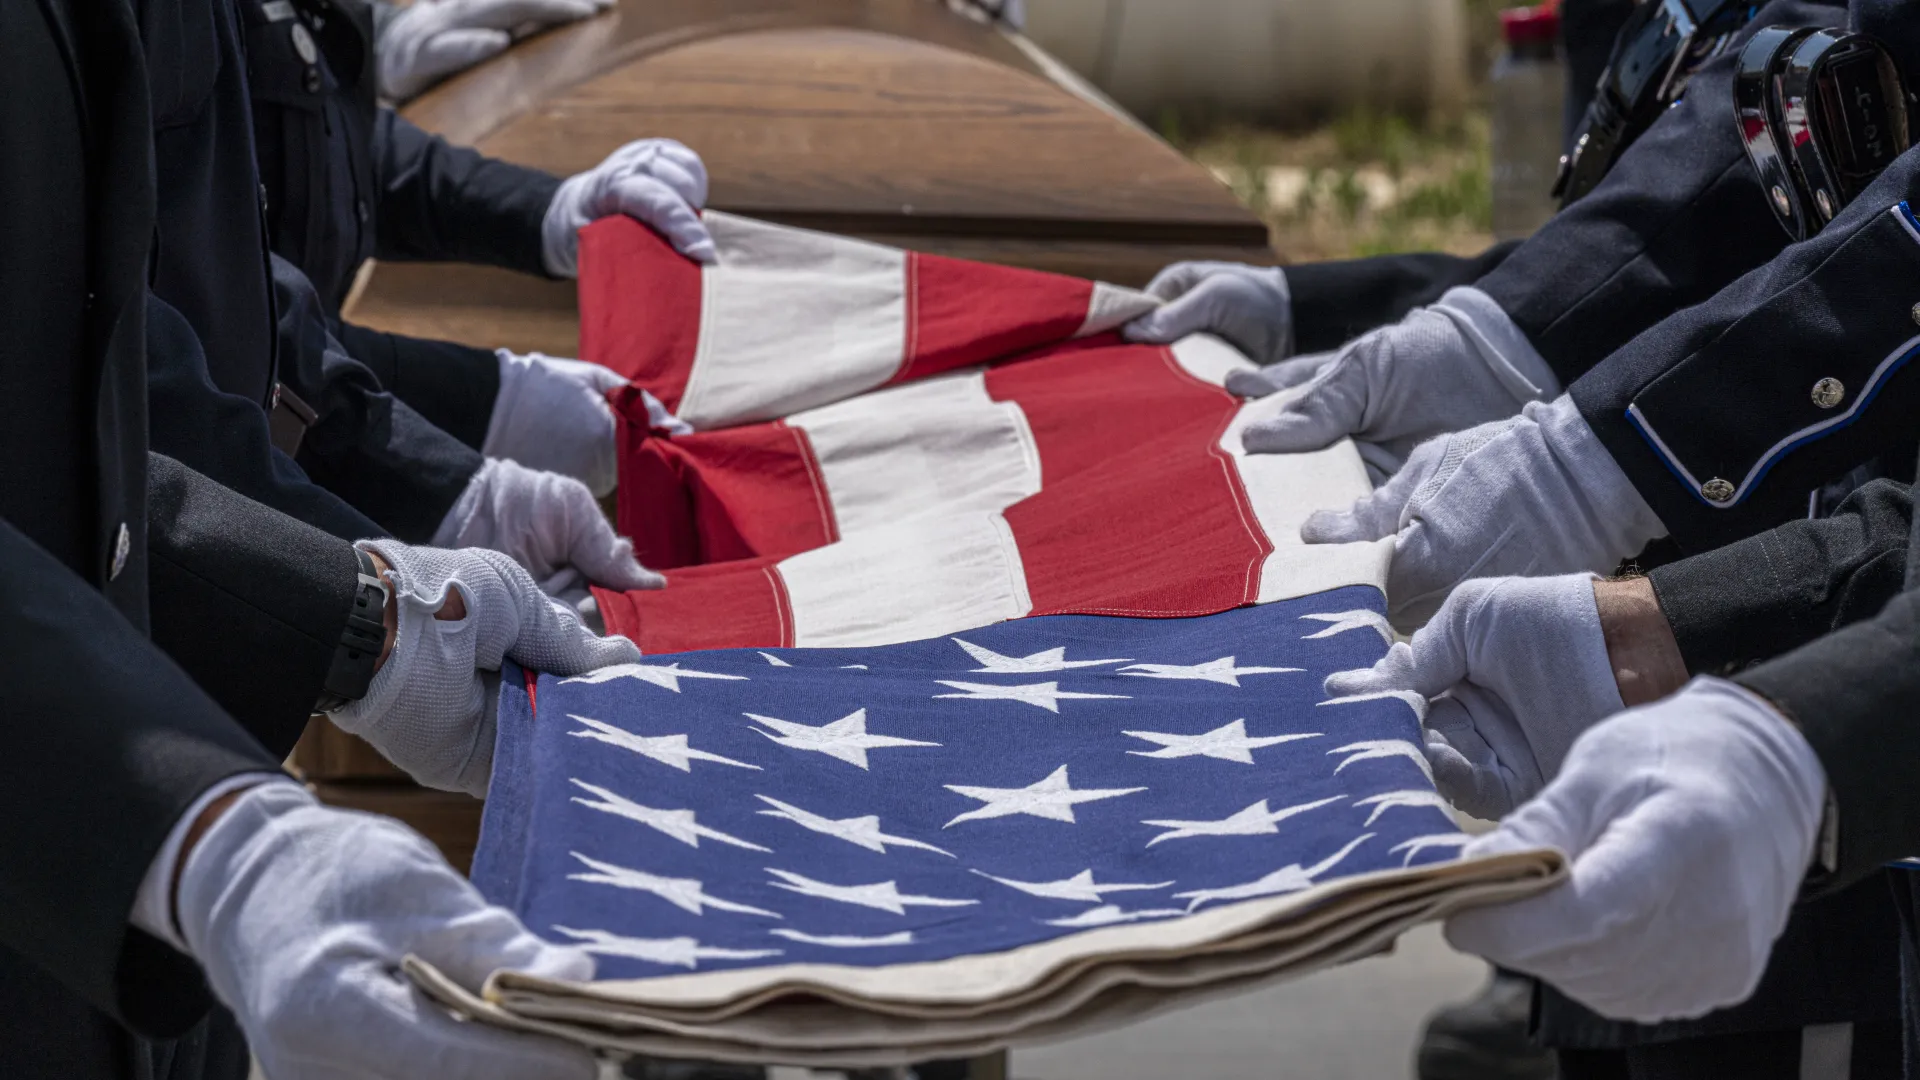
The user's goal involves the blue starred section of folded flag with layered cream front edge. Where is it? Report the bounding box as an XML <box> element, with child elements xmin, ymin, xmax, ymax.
<box><xmin>417</xmin><ymin>586</ymin><xmax>1553</xmax><ymax>1065</ymax></box>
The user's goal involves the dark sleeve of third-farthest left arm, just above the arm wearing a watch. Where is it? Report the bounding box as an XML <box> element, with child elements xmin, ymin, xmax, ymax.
<box><xmin>273</xmin><ymin>256</ymin><xmax>484</xmax><ymax>544</ymax></box>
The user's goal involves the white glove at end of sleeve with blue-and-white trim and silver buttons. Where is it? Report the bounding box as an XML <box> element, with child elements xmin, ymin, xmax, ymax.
<box><xmin>1300</xmin><ymin>394</ymin><xmax>1667</xmax><ymax>628</ymax></box>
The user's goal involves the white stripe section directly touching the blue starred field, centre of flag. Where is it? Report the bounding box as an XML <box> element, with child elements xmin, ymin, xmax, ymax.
<box><xmin>778</xmin><ymin>511</ymin><xmax>1033</xmax><ymax>648</ymax></box>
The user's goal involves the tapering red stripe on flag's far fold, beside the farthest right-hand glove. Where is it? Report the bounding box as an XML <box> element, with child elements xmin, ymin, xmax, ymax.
<box><xmin>891</xmin><ymin>252</ymin><xmax>1092</xmax><ymax>382</ymax></box>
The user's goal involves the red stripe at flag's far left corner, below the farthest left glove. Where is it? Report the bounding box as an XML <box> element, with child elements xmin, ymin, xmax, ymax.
<box><xmin>580</xmin><ymin>213</ymin><xmax>701</xmax><ymax>409</ymax></box>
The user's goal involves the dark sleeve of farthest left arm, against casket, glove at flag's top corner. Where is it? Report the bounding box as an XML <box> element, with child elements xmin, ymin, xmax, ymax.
<box><xmin>372</xmin><ymin>110</ymin><xmax>561</xmax><ymax>277</ymax></box>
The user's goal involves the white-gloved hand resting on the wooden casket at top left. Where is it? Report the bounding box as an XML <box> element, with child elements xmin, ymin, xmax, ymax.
<box><xmin>372</xmin><ymin>0</ymin><xmax>612</xmax><ymax>102</ymax></box>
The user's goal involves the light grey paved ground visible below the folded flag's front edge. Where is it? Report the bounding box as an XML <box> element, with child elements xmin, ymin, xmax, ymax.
<box><xmin>1012</xmin><ymin>926</ymin><xmax>1486</xmax><ymax>1080</ymax></box>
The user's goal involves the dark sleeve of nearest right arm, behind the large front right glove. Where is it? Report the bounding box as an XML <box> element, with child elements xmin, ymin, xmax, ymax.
<box><xmin>1738</xmin><ymin>592</ymin><xmax>1920</xmax><ymax>886</ymax></box>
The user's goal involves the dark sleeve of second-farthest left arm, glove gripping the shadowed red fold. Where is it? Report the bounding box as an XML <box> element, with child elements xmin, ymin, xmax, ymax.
<box><xmin>332</xmin><ymin>321</ymin><xmax>499</xmax><ymax>450</ymax></box>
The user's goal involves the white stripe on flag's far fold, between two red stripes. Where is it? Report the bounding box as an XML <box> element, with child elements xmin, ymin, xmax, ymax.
<box><xmin>678</xmin><ymin>211</ymin><xmax>906</xmax><ymax>429</ymax></box>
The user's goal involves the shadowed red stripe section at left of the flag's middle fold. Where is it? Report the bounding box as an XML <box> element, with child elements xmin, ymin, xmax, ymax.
<box><xmin>618</xmin><ymin>411</ymin><xmax>839</xmax><ymax>569</ymax></box>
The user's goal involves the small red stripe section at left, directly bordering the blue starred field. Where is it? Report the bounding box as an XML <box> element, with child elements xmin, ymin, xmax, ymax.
<box><xmin>593</xmin><ymin>559</ymin><xmax>793</xmax><ymax>655</ymax></box>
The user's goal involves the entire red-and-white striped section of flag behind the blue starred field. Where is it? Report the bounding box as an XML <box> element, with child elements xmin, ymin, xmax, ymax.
<box><xmin>582</xmin><ymin>213</ymin><xmax>1388</xmax><ymax>651</ymax></box>
